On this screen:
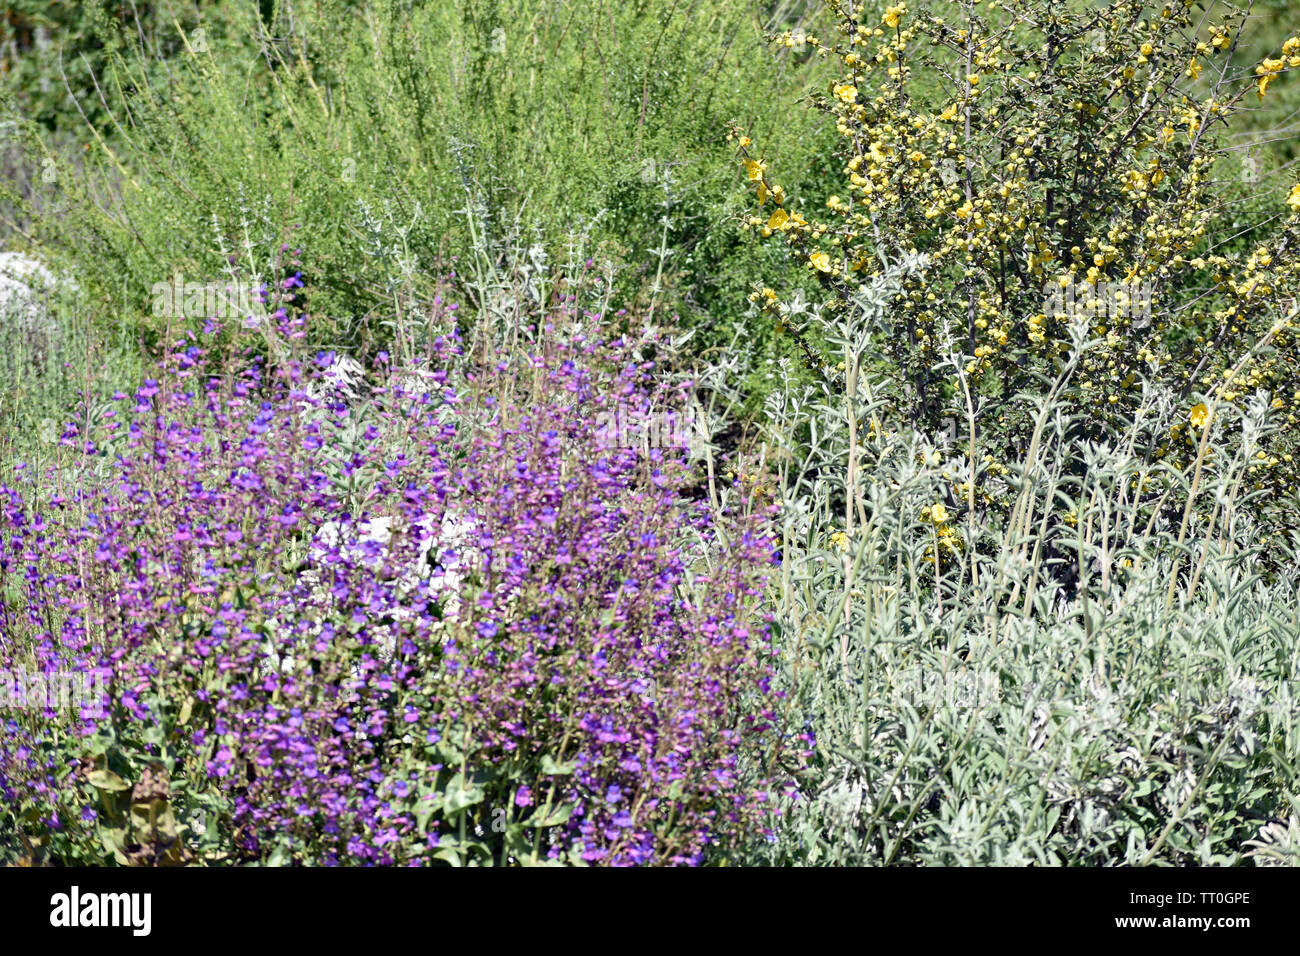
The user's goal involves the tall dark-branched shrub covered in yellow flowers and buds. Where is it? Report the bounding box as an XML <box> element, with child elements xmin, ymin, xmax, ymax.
<box><xmin>737</xmin><ymin>0</ymin><xmax>1300</xmax><ymax>522</ymax></box>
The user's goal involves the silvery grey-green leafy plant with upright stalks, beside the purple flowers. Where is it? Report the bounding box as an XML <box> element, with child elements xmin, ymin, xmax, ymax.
<box><xmin>743</xmin><ymin>261</ymin><xmax>1300</xmax><ymax>865</ymax></box>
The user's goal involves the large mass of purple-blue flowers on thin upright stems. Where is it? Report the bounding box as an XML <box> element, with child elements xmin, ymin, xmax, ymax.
<box><xmin>0</xmin><ymin>299</ymin><xmax>780</xmax><ymax>864</ymax></box>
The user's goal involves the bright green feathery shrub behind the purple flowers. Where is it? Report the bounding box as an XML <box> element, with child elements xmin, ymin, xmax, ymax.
<box><xmin>5</xmin><ymin>0</ymin><xmax>826</xmax><ymax>369</ymax></box>
